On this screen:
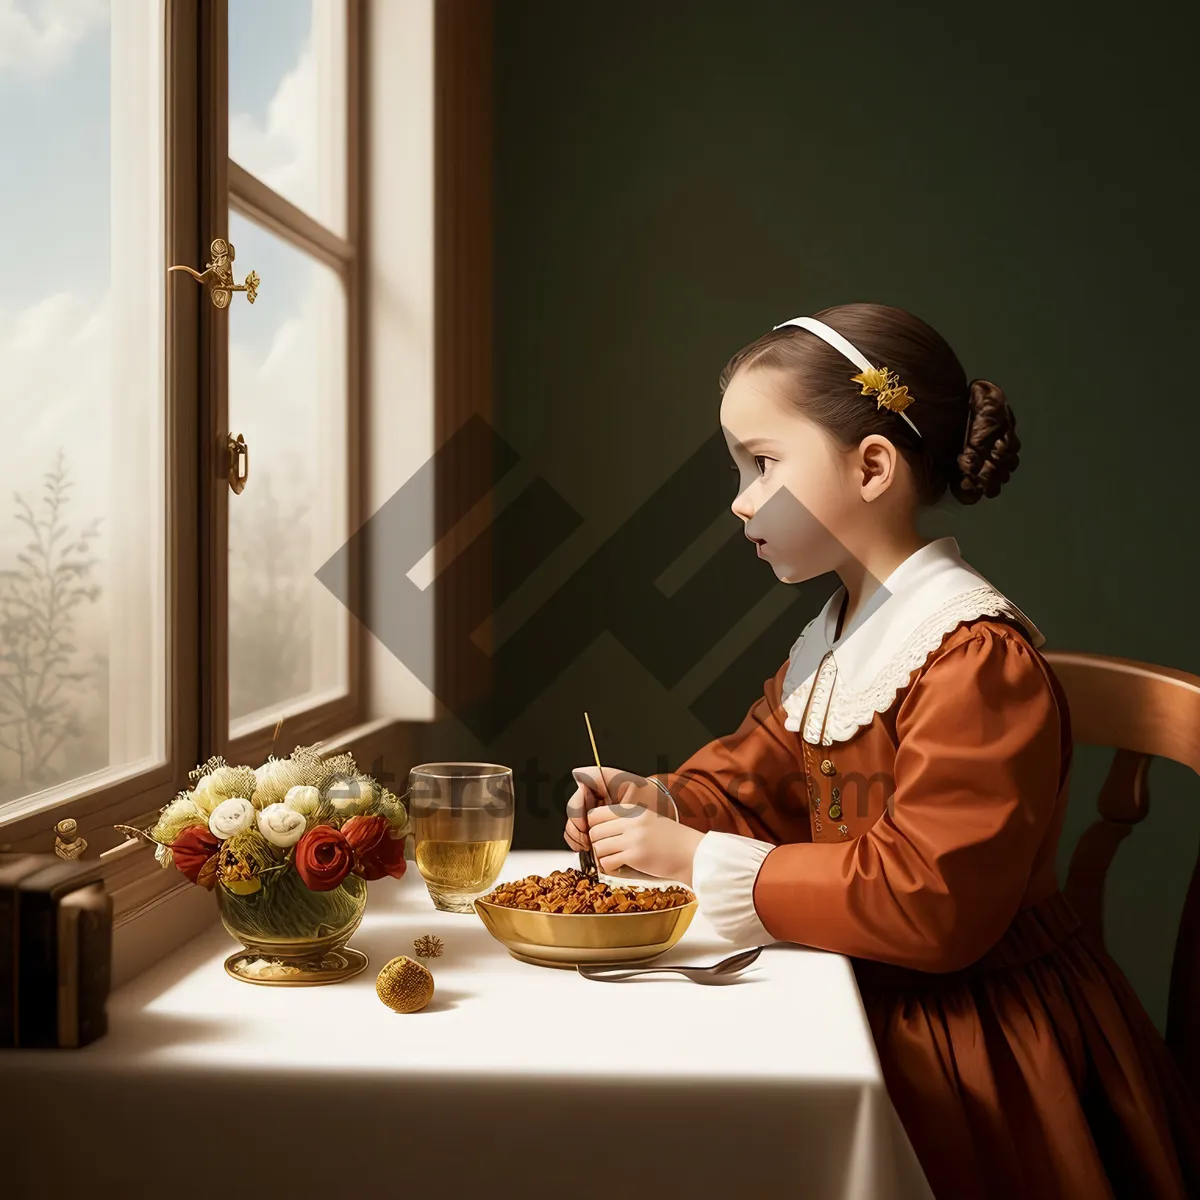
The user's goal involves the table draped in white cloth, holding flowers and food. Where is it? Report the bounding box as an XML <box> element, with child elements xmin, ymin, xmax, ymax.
<box><xmin>0</xmin><ymin>851</ymin><xmax>930</xmax><ymax>1200</ymax></box>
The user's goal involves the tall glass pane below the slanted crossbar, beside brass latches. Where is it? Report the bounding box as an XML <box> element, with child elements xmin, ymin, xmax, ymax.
<box><xmin>229</xmin><ymin>214</ymin><xmax>349</xmax><ymax>737</ymax></box>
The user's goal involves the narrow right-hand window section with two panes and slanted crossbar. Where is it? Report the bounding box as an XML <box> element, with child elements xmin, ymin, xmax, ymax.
<box><xmin>215</xmin><ymin>0</ymin><xmax>362</xmax><ymax>761</ymax></box>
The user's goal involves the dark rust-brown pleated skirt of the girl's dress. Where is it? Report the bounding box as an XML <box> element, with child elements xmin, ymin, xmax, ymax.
<box><xmin>854</xmin><ymin>893</ymin><xmax>1200</xmax><ymax>1200</ymax></box>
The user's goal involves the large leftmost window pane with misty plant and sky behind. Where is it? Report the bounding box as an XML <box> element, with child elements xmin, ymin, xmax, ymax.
<box><xmin>0</xmin><ymin>0</ymin><xmax>167</xmax><ymax>815</ymax></box>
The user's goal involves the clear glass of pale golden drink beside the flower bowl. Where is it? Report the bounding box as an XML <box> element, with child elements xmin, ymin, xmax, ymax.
<box><xmin>408</xmin><ymin>762</ymin><xmax>514</xmax><ymax>912</ymax></box>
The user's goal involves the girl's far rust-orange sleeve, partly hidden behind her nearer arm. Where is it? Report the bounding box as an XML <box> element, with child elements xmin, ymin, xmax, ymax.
<box><xmin>650</xmin><ymin>662</ymin><xmax>804</xmax><ymax>845</ymax></box>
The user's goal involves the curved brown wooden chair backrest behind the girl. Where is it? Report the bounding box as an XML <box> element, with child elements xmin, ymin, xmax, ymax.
<box><xmin>1045</xmin><ymin>653</ymin><xmax>1200</xmax><ymax>1094</ymax></box>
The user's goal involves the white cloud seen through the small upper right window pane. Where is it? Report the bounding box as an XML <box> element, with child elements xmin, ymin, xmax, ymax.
<box><xmin>229</xmin><ymin>38</ymin><xmax>320</xmax><ymax>216</ymax></box>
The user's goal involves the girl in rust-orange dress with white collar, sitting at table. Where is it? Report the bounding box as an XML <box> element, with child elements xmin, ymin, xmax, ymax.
<box><xmin>565</xmin><ymin>305</ymin><xmax>1200</xmax><ymax>1200</ymax></box>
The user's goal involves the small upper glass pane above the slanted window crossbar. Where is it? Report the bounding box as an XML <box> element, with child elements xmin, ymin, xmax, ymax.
<box><xmin>229</xmin><ymin>0</ymin><xmax>347</xmax><ymax>236</ymax></box>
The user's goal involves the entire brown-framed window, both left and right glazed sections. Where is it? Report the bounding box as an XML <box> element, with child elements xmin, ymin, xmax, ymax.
<box><xmin>0</xmin><ymin>0</ymin><xmax>364</xmax><ymax>857</ymax></box>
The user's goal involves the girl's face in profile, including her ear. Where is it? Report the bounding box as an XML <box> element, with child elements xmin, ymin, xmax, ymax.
<box><xmin>721</xmin><ymin>367</ymin><xmax>902</xmax><ymax>583</ymax></box>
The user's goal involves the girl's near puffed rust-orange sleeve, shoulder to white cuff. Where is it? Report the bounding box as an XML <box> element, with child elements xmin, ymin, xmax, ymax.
<box><xmin>754</xmin><ymin>626</ymin><xmax>1062</xmax><ymax>971</ymax></box>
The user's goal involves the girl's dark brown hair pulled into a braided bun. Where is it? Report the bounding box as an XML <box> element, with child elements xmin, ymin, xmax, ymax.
<box><xmin>720</xmin><ymin>304</ymin><xmax>1021</xmax><ymax>504</ymax></box>
